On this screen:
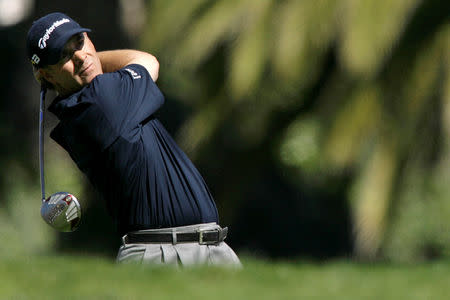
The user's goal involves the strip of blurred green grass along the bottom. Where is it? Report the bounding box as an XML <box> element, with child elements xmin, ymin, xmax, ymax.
<box><xmin>0</xmin><ymin>255</ymin><xmax>450</xmax><ymax>300</ymax></box>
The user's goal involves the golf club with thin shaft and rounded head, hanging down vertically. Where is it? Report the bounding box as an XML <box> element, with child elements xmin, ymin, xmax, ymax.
<box><xmin>39</xmin><ymin>86</ymin><xmax>81</xmax><ymax>232</ymax></box>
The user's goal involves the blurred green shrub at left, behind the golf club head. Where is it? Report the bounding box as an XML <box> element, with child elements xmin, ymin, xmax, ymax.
<box><xmin>0</xmin><ymin>143</ymin><xmax>84</xmax><ymax>257</ymax></box>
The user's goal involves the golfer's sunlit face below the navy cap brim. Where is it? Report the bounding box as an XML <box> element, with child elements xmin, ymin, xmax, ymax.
<box><xmin>42</xmin><ymin>32</ymin><xmax>103</xmax><ymax>96</ymax></box>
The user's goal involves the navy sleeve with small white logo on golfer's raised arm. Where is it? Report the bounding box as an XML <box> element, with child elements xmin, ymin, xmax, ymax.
<box><xmin>88</xmin><ymin>64</ymin><xmax>164</xmax><ymax>136</ymax></box>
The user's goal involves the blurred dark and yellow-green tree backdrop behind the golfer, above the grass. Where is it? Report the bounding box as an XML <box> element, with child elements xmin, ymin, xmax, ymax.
<box><xmin>0</xmin><ymin>0</ymin><xmax>450</xmax><ymax>261</ymax></box>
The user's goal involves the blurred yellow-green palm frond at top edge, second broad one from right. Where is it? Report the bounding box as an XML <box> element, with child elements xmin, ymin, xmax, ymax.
<box><xmin>272</xmin><ymin>0</ymin><xmax>338</xmax><ymax>88</ymax></box>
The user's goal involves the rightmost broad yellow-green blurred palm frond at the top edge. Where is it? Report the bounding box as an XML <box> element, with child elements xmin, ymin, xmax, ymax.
<box><xmin>339</xmin><ymin>0</ymin><xmax>422</xmax><ymax>77</ymax></box>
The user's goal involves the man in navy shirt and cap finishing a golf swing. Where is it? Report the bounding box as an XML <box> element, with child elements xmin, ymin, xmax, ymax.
<box><xmin>27</xmin><ymin>13</ymin><xmax>240</xmax><ymax>266</ymax></box>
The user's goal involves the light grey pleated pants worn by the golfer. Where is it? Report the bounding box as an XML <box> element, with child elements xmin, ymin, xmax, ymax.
<box><xmin>117</xmin><ymin>223</ymin><xmax>242</xmax><ymax>267</ymax></box>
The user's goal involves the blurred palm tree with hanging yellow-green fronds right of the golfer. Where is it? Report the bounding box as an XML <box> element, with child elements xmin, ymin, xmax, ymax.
<box><xmin>142</xmin><ymin>0</ymin><xmax>450</xmax><ymax>258</ymax></box>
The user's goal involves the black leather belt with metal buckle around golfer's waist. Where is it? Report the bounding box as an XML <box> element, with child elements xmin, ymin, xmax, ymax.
<box><xmin>123</xmin><ymin>227</ymin><xmax>228</xmax><ymax>245</ymax></box>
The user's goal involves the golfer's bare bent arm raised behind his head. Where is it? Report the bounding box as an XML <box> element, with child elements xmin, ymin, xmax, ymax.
<box><xmin>97</xmin><ymin>49</ymin><xmax>159</xmax><ymax>82</ymax></box>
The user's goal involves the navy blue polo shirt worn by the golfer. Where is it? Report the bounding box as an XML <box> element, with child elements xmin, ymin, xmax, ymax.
<box><xmin>49</xmin><ymin>64</ymin><xmax>218</xmax><ymax>234</ymax></box>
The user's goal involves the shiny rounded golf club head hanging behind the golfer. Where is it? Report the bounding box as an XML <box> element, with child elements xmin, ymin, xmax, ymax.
<box><xmin>41</xmin><ymin>192</ymin><xmax>81</xmax><ymax>232</ymax></box>
